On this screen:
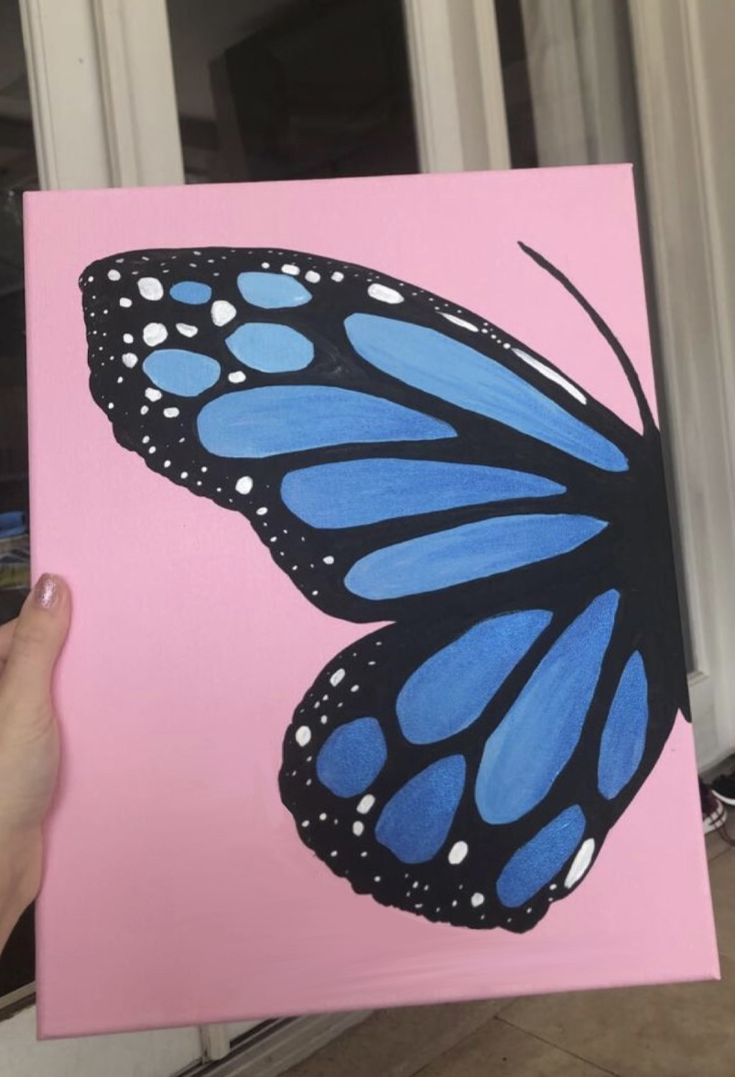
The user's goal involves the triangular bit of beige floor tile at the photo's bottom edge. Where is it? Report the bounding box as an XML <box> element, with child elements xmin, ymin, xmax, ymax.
<box><xmin>419</xmin><ymin>1018</ymin><xmax>609</xmax><ymax>1077</ymax></box>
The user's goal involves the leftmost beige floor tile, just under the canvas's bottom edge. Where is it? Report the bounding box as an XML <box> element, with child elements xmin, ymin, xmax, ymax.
<box><xmin>287</xmin><ymin>999</ymin><xmax>508</xmax><ymax>1077</ymax></box>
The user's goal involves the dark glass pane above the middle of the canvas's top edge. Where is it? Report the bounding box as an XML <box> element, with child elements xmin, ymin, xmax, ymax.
<box><xmin>168</xmin><ymin>0</ymin><xmax>418</xmax><ymax>183</ymax></box>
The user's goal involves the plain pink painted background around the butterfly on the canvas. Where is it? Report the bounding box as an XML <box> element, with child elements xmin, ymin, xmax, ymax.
<box><xmin>26</xmin><ymin>167</ymin><xmax>718</xmax><ymax>1036</ymax></box>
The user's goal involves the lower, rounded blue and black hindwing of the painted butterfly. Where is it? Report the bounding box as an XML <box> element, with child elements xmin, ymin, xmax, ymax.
<box><xmin>280</xmin><ymin>591</ymin><xmax>674</xmax><ymax>932</ymax></box>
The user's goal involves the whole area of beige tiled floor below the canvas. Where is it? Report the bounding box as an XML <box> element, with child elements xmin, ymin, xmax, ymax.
<box><xmin>287</xmin><ymin>835</ymin><xmax>735</xmax><ymax>1077</ymax></box>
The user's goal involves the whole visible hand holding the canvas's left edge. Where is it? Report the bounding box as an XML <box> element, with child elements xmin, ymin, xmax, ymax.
<box><xmin>0</xmin><ymin>575</ymin><xmax>71</xmax><ymax>949</ymax></box>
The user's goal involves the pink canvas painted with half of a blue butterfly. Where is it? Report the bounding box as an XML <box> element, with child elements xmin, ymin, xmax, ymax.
<box><xmin>27</xmin><ymin>166</ymin><xmax>717</xmax><ymax>1035</ymax></box>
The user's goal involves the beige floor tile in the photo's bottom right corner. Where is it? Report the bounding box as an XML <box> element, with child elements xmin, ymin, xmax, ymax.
<box><xmin>502</xmin><ymin>957</ymin><xmax>735</xmax><ymax>1077</ymax></box>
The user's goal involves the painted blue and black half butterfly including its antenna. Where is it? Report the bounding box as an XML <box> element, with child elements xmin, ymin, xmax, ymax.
<box><xmin>80</xmin><ymin>244</ymin><xmax>688</xmax><ymax>932</ymax></box>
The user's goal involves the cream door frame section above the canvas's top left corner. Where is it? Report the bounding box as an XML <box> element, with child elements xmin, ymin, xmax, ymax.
<box><xmin>19</xmin><ymin>0</ymin><xmax>183</xmax><ymax>188</ymax></box>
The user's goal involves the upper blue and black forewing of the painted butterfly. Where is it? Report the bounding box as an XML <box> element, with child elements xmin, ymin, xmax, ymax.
<box><xmin>81</xmin><ymin>250</ymin><xmax>642</xmax><ymax>620</ymax></box>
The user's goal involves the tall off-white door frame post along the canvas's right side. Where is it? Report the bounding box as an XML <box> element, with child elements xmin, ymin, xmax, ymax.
<box><xmin>629</xmin><ymin>0</ymin><xmax>735</xmax><ymax>768</ymax></box>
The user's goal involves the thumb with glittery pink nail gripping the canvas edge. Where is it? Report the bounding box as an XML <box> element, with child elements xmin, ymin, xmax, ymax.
<box><xmin>2</xmin><ymin>574</ymin><xmax>71</xmax><ymax>710</ymax></box>
